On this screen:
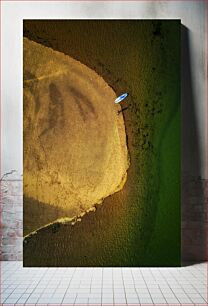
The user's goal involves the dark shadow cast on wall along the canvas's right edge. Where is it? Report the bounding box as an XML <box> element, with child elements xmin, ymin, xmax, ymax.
<box><xmin>181</xmin><ymin>25</ymin><xmax>207</xmax><ymax>266</ymax></box>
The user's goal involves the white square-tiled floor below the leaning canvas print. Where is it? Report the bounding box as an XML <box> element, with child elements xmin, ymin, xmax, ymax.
<box><xmin>0</xmin><ymin>262</ymin><xmax>207</xmax><ymax>305</ymax></box>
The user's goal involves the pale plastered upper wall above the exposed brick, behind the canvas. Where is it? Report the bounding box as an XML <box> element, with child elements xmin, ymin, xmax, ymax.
<box><xmin>1</xmin><ymin>1</ymin><xmax>208</xmax><ymax>179</ymax></box>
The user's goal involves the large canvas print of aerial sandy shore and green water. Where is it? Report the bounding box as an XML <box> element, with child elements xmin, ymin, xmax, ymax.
<box><xmin>23</xmin><ymin>20</ymin><xmax>181</xmax><ymax>267</ymax></box>
